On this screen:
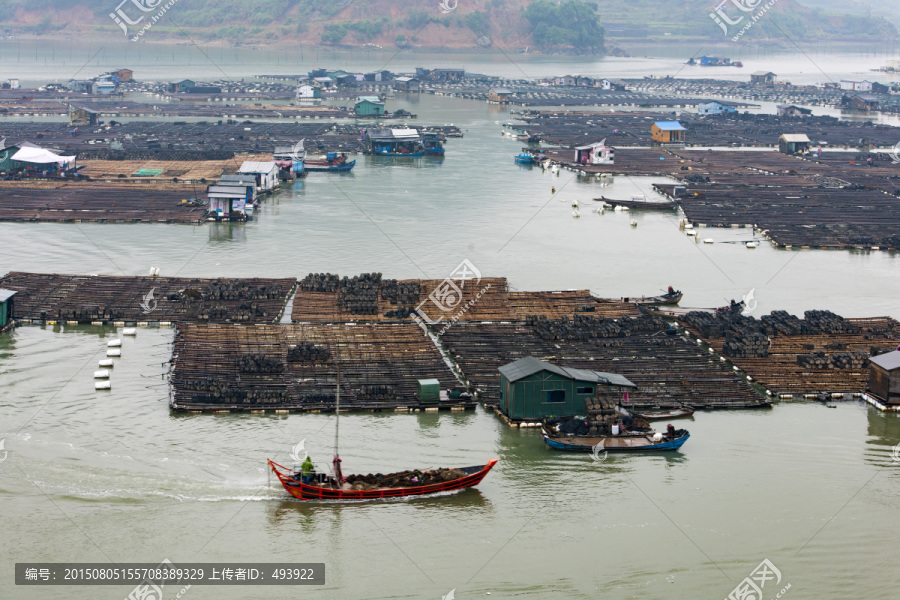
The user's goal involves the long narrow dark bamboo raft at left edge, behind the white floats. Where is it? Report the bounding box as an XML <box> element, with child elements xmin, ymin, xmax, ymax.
<box><xmin>0</xmin><ymin>272</ymin><xmax>297</xmax><ymax>325</ymax></box>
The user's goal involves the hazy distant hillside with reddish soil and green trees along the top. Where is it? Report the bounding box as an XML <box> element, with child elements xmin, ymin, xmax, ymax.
<box><xmin>0</xmin><ymin>0</ymin><xmax>900</xmax><ymax>53</ymax></box>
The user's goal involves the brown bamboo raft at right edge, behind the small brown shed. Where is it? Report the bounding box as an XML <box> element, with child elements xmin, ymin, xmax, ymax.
<box><xmin>680</xmin><ymin>317</ymin><xmax>900</xmax><ymax>396</ymax></box>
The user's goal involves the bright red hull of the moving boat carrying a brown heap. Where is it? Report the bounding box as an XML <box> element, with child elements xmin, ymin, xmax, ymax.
<box><xmin>269</xmin><ymin>458</ymin><xmax>497</xmax><ymax>500</ymax></box>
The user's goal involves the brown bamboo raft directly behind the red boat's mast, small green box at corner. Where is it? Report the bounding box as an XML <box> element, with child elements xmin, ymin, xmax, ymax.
<box><xmin>171</xmin><ymin>323</ymin><xmax>475</xmax><ymax>412</ymax></box>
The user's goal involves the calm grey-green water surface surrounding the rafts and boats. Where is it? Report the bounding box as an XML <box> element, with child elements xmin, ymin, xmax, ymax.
<box><xmin>0</xmin><ymin>40</ymin><xmax>900</xmax><ymax>600</ymax></box>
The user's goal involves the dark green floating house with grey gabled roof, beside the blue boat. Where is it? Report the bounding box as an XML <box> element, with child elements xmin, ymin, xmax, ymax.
<box><xmin>498</xmin><ymin>356</ymin><xmax>637</xmax><ymax>421</ymax></box>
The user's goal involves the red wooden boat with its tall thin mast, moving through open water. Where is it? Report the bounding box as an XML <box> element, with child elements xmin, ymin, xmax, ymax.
<box><xmin>268</xmin><ymin>366</ymin><xmax>497</xmax><ymax>500</ymax></box>
